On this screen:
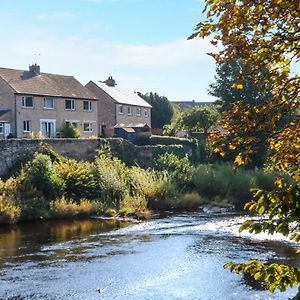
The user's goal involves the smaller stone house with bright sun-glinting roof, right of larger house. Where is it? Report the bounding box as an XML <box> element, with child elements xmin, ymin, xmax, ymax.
<box><xmin>86</xmin><ymin>77</ymin><xmax>152</xmax><ymax>135</ymax></box>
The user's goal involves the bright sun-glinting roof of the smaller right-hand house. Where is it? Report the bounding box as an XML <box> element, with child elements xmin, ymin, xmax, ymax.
<box><xmin>88</xmin><ymin>82</ymin><xmax>152</xmax><ymax>108</ymax></box>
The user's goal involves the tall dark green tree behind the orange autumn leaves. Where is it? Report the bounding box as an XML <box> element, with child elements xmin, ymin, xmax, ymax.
<box><xmin>209</xmin><ymin>59</ymin><xmax>271</xmax><ymax>111</ymax></box>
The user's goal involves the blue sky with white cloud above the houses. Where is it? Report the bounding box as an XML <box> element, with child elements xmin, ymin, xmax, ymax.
<box><xmin>0</xmin><ymin>0</ymin><xmax>215</xmax><ymax>101</ymax></box>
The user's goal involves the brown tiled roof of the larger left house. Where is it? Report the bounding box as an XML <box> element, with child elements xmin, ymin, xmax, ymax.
<box><xmin>0</xmin><ymin>68</ymin><xmax>97</xmax><ymax>100</ymax></box>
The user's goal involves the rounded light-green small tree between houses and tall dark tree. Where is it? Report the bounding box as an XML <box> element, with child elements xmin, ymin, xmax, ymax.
<box><xmin>180</xmin><ymin>106</ymin><xmax>219</xmax><ymax>134</ymax></box>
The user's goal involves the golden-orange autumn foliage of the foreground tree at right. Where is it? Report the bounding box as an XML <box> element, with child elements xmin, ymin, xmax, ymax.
<box><xmin>190</xmin><ymin>0</ymin><xmax>300</xmax><ymax>297</ymax></box>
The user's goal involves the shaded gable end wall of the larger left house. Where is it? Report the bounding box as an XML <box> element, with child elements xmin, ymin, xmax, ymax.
<box><xmin>0</xmin><ymin>77</ymin><xmax>16</xmax><ymax>134</ymax></box>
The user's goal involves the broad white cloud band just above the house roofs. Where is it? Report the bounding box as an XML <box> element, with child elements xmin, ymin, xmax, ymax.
<box><xmin>0</xmin><ymin>32</ymin><xmax>214</xmax><ymax>100</ymax></box>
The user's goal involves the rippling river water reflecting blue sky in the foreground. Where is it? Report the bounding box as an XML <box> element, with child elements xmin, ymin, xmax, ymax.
<box><xmin>0</xmin><ymin>212</ymin><xmax>300</xmax><ymax>300</ymax></box>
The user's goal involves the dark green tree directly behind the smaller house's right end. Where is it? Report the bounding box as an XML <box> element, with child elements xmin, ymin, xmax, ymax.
<box><xmin>138</xmin><ymin>92</ymin><xmax>174</xmax><ymax>128</ymax></box>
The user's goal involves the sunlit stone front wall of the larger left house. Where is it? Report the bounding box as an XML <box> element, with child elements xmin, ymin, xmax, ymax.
<box><xmin>16</xmin><ymin>95</ymin><xmax>98</xmax><ymax>138</ymax></box>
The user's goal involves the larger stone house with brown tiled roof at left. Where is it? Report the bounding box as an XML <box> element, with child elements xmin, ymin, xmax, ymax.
<box><xmin>0</xmin><ymin>64</ymin><xmax>98</xmax><ymax>138</ymax></box>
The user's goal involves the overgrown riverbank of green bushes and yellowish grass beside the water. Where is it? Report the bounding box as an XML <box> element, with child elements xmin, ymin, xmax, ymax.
<box><xmin>0</xmin><ymin>151</ymin><xmax>276</xmax><ymax>223</ymax></box>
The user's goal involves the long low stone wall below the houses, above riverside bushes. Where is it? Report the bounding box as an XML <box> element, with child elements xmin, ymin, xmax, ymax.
<box><xmin>0</xmin><ymin>138</ymin><xmax>193</xmax><ymax>176</ymax></box>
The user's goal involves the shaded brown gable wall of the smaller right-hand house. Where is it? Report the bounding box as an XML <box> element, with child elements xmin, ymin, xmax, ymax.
<box><xmin>86</xmin><ymin>82</ymin><xmax>116</xmax><ymax>135</ymax></box>
